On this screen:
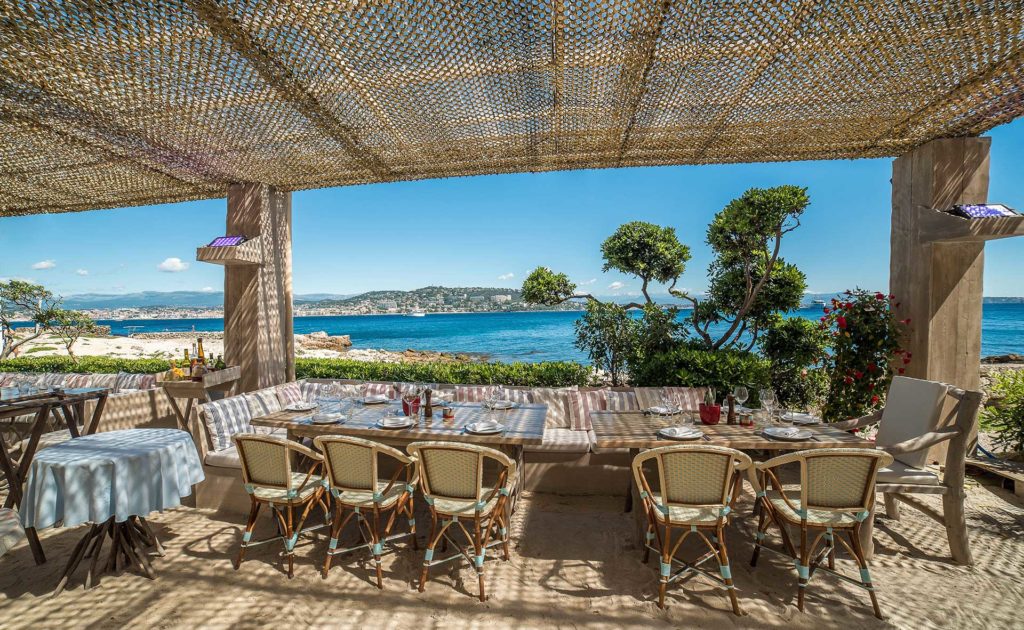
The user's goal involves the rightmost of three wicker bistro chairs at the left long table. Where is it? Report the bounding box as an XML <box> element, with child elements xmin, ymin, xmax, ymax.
<box><xmin>409</xmin><ymin>442</ymin><xmax>516</xmax><ymax>601</ymax></box>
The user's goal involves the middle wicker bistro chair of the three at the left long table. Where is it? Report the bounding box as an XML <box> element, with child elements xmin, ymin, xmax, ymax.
<box><xmin>313</xmin><ymin>435</ymin><xmax>417</xmax><ymax>588</ymax></box>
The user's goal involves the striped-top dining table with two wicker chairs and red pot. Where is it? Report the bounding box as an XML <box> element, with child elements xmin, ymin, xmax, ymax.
<box><xmin>590</xmin><ymin>411</ymin><xmax>874</xmax><ymax>554</ymax></box>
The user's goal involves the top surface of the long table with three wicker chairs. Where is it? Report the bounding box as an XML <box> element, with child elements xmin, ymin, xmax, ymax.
<box><xmin>252</xmin><ymin>403</ymin><xmax>548</xmax><ymax>446</ymax></box>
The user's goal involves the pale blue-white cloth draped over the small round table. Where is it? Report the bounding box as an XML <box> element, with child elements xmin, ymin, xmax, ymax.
<box><xmin>20</xmin><ymin>429</ymin><xmax>205</xmax><ymax>529</ymax></box>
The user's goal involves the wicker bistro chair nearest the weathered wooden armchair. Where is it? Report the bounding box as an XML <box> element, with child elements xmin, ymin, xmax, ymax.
<box><xmin>751</xmin><ymin>449</ymin><xmax>893</xmax><ymax>619</ymax></box>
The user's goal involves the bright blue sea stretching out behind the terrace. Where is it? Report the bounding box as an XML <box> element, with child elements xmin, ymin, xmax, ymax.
<box><xmin>90</xmin><ymin>303</ymin><xmax>1024</xmax><ymax>363</ymax></box>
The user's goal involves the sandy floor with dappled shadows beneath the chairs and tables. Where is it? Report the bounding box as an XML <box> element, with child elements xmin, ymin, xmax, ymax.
<box><xmin>0</xmin><ymin>481</ymin><xmax>1024</xmax><ymax>629</ymax></box>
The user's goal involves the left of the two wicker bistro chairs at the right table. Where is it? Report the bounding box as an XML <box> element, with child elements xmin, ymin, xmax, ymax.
<box><xmin>633</xmin><ymin>445</ymin><xmax>751</xmax><ymax>615</ymax></box>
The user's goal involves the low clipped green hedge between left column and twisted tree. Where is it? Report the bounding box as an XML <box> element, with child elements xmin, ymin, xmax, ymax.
<box><xmin>295</xmin><ymin>359</ymin><xmax>593</xmax><ymax>387</ymax></box>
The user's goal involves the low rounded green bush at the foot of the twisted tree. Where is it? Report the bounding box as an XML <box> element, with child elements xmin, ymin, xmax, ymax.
<box><xmin>632</xmin><ymin>343</ymin><xmax>769</xmax><ymax>397</ymax></box>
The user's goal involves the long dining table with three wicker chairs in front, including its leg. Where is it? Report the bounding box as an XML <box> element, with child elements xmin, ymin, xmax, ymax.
<box><xmin>252</xmin><ymin>400</ymin><xmax>548</xmax><ymax>509</ymax></box>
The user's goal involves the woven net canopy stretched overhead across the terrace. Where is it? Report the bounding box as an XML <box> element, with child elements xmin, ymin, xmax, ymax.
<box><xmin>0</xmin><ymin>0</ymin><xmax>1024</xmax><ymax>215</ymax></box>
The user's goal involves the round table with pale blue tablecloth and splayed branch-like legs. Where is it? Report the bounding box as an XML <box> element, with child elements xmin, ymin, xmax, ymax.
<box><xmin>20</xmin><ymin>429</ymin><xmax>205</xmax><ymax>594</ymax></box>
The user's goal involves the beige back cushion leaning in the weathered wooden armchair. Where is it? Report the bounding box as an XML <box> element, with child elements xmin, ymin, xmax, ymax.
<box><xmin>874</xmin><ymin>376</ymin><xmax>946</xmax><ymax>468</ymax></box>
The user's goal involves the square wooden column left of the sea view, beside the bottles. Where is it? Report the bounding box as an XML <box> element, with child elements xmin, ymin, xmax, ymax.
<box><xmin>224</xmin><ymin>183</ymin><xmax>295</xmax><ymax>391</ymax></box>
